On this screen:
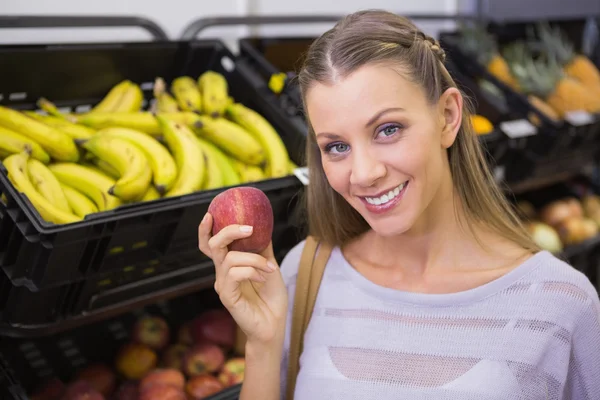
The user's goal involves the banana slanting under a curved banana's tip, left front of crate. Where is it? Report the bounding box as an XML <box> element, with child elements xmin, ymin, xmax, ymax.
<box><xmin>48</xmin><ymin>162</ymin><xmax>122</xmax><ymax>211</ymax></box>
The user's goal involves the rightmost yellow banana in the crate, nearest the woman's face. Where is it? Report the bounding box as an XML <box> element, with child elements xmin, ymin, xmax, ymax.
<box><xmin>227</xmin><ymin>103</ymin><xmax>290</xmax><ymax>178</ymax></box>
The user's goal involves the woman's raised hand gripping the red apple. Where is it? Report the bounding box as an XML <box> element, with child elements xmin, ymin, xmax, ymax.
<box><xmin>198</xmin><ymin>214</ymin><xmax>288</xmax><ymax>344</ymax></box>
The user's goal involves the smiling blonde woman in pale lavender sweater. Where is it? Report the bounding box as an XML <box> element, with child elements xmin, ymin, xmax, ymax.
<box><xmin>199</xmin><ymin>11</ymin><xmax>600</xmax><ymax>400</ymax></box>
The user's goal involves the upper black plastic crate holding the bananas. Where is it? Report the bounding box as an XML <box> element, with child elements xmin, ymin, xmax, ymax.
<box><xmin>0</xmin><ymin>40</ymin><xmax>304</xmax><ymax>290</ymax></box>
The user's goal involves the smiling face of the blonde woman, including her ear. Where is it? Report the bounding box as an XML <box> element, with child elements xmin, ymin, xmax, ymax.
<box><xmin>306</xmin><ymin>65</ymin><xmax>462</xmax><ymax>236</ymax></box>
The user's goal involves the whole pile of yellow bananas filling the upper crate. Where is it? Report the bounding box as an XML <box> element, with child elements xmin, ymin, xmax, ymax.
<box><xmin>0</xmin><ymin>71</ymin><xmax>297</xmax><ymax>224</ymax></box>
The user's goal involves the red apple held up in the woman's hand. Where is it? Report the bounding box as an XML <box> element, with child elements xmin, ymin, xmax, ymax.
<box><xmin>208</xmin><ymin>186</ymin><xmax>273</xmax><ymax>253</ymax></box>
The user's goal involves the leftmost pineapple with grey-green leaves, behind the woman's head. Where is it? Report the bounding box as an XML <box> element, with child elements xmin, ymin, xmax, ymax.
<box><xmin>458</xmin><ymin>25</ymin><xmax>520</xmax><ymax>91</ymax></box>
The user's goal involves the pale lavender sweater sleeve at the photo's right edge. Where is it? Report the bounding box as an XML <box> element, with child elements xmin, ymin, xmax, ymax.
<box><xmin>565</xmin><ymin>290</ymin><xmax>600</xmax><ymax>400</ymax></box>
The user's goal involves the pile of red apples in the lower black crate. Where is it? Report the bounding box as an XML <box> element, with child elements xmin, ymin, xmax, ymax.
<box><xmin>30</xmin><ymin>309</ymin><xmax>245</xmax><ymax>400</ymax></box>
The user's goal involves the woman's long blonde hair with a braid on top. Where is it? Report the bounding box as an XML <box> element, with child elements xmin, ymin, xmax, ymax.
<box><xmin>298</xmin><ymin>10</ymin><xmax>539</xmax><ymax>251</ymax></box>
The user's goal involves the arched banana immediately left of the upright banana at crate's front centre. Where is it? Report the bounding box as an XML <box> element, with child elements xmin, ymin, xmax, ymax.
<box><xmin>98</xmin><ymin>128</ymin><xmax>177</xmax><ymax>193</ymax></box>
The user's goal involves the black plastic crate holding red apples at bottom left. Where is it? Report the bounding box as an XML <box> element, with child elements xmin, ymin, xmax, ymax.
<box><xmin>0</xmin><ymin>289</ymin><xmax>241</xmax><ymax>400</ymax></box>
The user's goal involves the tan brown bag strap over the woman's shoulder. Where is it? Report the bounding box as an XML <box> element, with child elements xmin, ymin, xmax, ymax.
<box><xmin>286</xmin><ymin>236</ymin><xmax>332</xmax><ymax>400</ymax></box>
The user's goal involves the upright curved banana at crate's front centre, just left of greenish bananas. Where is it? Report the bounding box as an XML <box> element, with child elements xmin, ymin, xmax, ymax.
<box><xmin>156</xmin><ymin>115</ymin><xmax>206</xmax><ymax>197</ymax></box>
